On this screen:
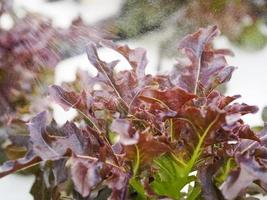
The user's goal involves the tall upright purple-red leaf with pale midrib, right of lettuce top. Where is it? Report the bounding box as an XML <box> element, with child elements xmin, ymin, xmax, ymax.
<box><xmin>174</xmin><ymin>26</ymin><xmax>234</xmax><ymax>94</ymax></box>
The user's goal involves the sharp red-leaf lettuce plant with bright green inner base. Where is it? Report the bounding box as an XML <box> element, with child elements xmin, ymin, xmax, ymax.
<box><xmin>0</xmin><ymin>26</ymin><xmax>267</xmax><ymax>200</ymax></box>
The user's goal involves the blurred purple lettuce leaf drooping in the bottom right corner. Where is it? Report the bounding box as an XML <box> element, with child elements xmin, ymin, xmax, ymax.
<box><xmin>222</xmin><ymin>127</ymin><xmax>267</xmax><ymax>199</ymax></box>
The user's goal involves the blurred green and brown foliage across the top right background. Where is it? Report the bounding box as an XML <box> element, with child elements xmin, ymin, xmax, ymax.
<box><xmin>100</xmin><ymin>0</ymin><xmax>267</xmax><ymax>49</ymax></box>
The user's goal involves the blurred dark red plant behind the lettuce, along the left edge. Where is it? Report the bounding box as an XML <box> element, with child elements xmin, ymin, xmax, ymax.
<box><xmin>0</xmin><ymin>0</ymin><xmax>110</xmax><ymax>166</ymax></box>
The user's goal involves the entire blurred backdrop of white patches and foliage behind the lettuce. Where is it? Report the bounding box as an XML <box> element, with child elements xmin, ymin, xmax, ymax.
<box><xmin>0</xmin><ymin>0</ymin><xmax>267</xmax><ymax>200</ymax></box>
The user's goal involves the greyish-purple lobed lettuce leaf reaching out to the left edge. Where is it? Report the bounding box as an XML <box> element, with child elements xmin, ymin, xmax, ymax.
<box><xmin>0</xmin><ymin>112</ymin><xmax>97</xmax><ymax>176</ymax></box>
